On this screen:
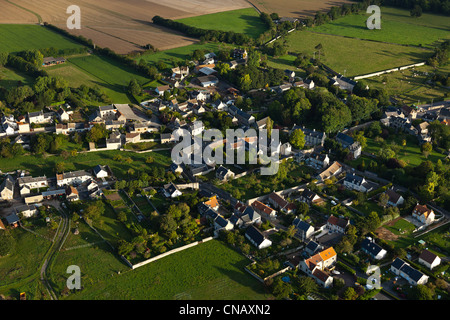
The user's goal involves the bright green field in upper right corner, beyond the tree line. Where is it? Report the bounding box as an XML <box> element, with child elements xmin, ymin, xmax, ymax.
<box><xmin>313</xmin><ymin>7</ymin><xmax>450</xmax><ymax>46</ymax></box>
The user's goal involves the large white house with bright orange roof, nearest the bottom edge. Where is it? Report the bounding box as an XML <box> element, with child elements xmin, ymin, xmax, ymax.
<box><xmin>298</xmin><ymin>247</ymin><xmax>337</xmax><ymax>288</ymax></box>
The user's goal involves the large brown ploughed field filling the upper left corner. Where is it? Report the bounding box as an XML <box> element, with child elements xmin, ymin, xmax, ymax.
<box><xmin>0</xmin><ymin>0</ymin><xmax>251</xmax><ymax>54</ymax></box>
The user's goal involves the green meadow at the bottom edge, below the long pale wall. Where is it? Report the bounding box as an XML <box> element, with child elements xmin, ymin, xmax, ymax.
<box><xmin>50</xmin><ymin>240</ymin><xmax>270</xmax><ymax>300</ymax></box>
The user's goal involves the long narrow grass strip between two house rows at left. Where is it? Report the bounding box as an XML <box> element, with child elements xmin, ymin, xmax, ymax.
<box><xmin>0</xmin><ymin>150</ymin><xmax>171</xmax><ymax>180</ymax></box>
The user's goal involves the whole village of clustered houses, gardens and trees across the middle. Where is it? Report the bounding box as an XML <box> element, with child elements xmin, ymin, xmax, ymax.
<box><xmin>0</xmin><ymin>44</ymin><xmax>450</xmax><ymax>299</ymax></box>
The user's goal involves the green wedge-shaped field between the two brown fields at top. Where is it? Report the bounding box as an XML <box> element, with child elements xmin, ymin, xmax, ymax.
<box><xmin>177</xmin><ymin>8</ymin><xmax>267</xmax><ymax>38</ymax></box>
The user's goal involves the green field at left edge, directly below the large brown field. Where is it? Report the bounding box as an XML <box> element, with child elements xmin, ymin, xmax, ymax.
<box><xmin>0</xmin><ymin>24</ymin><xmax>82</xmax><ymax>52</ymax></box>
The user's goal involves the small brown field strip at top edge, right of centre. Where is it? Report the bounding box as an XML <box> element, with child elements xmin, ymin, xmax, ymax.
<box><xmin>250</xmin><ymin>0</ymin><xmax>352</xmax><ymax>18</ymax></box>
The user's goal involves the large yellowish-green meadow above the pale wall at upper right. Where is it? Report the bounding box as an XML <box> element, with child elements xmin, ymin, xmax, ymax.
<box><xmin>269</xmin><ymin>29</ymin><xmax>432</xmax><ymax>77</ymax></box>
